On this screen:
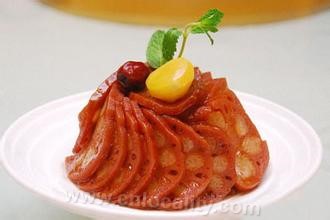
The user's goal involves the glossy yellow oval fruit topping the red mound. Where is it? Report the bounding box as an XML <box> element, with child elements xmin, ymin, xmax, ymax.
<box><xmin>146</xmin><ymin>57</ymin><xmax>194</xmax><ymax>102</ymax></box>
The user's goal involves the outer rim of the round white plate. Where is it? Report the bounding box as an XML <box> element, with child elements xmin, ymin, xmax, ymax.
<box><xmin>0</xmin><ymin>90</ymin><xmax>323</xmax><ymax>218</ymax></box>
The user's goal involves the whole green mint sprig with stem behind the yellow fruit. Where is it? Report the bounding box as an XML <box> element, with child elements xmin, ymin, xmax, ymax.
<box><xmin>146</xmin><ymin>9</ymin><xmax>223</xmax><ymax>68</ymax></box>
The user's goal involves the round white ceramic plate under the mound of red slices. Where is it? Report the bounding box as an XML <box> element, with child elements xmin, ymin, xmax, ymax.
<box><xmin>0</xmin><ymin>92</ymin><xmax>322</xmax><ymax>220</ymax></box>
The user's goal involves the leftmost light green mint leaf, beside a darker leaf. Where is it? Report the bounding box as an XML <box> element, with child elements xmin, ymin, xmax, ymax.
<box><xmin>146</xmin><ymin>30</ymin><xmax>165</xmax><ymax>68</ymax></box>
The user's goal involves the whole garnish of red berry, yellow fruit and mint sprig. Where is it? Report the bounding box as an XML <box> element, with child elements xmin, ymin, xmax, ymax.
<box><xmin>117</xmin><ymin>9</ymin><xmax>223</xmax><ymax>102</ymax></box>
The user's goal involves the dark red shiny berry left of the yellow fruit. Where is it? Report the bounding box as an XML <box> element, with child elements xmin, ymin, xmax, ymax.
<box><xmin>117</xmin><ymin>61</ymin><xmax>151</xmax><ymax>91</ymax></box>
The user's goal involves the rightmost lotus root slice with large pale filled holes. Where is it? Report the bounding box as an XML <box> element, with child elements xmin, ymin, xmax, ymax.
<box><xmin>212</xmin><ymin>89</ymin><xmax>269</xmax><ymax>191</ymax></box>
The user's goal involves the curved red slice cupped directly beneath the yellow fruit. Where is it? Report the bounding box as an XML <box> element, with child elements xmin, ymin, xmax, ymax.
<box><xmin>130</xmin><ymin>68</ymin><xmax>210</xmax><ymax>115</ymax></box>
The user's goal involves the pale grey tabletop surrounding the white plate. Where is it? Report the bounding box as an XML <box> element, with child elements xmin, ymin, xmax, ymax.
<box><xmin>0</xmin><ymin>0</ymin><xmax>330</xmax><ymax>220</ymax></box>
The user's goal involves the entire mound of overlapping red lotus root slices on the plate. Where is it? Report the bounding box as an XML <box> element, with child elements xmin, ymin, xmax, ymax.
<box><xmin>65</xmin><ymin>68</ymin><xmax>269</xmax><ymax>210</ymax></box>
